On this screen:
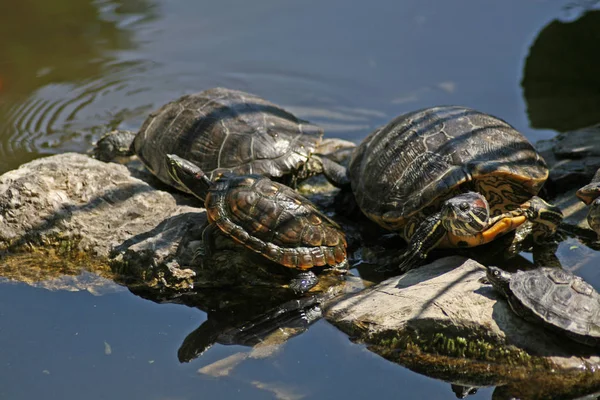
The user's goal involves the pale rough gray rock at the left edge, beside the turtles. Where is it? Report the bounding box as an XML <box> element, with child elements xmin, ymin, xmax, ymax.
<box><xmin>0</xmin><ymin>153</ymin><xmax>205</xmax><ymax>288</ymax></box>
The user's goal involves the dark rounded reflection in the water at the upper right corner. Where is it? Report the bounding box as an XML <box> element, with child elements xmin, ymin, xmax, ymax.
<box><xmin>521</xmin><ymin>10</ymin><xmax>600</xmax><ymax>132</ymax></box>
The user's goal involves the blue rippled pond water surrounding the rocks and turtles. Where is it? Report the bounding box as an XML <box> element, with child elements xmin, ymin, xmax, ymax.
<box><xmin>0</xmin><ymin>0</ymin><xmax>600</xmax><ymax>400</ymax></box>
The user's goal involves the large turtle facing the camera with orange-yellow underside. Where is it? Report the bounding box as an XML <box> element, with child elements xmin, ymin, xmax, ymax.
<box><xmin>348</xmin><ymin>106</ymin><xmax>562</xmax><ymax>271</ymax></box>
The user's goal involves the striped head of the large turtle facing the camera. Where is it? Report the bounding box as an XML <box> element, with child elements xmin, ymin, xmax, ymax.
<box><xmin>441</xmin><ymin>192</ymin><xmax>490</xmax><ymax>236</ymax></box>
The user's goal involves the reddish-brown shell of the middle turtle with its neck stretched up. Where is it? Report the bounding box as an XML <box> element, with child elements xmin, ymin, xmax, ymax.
<box><xmin>205</xmin><ymin>175</ymin><xmax>347</xmax><ymax>269</ymax></box>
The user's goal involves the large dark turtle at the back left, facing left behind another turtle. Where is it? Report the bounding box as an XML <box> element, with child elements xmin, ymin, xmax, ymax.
<box><xmin>93</xmin><ymin>87</ymin><xmax>354</xmax><ymax>191</ymax></box>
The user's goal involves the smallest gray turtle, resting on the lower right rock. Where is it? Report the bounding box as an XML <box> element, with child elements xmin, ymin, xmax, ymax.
<box><xmin>487</xmin><ymin>267</ymin><xmax>600</xmax><ymax>346</ymax></box>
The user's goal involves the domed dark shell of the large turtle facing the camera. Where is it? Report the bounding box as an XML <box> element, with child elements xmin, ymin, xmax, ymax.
<box><xmin>349</xmin><ymin>106</ymin><xmax>548</xmax><ymax>230</ymax></box>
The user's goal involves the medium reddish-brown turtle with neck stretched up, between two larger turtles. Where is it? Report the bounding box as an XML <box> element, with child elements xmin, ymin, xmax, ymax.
<box><xmin>166</xmin><ymin>154</ymin><xmax>347</xmax><ymax>292</ymax></box>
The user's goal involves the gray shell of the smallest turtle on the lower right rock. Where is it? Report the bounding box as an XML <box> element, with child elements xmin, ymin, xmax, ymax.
<box><xmin>510</xmin><ymin>268</ymin><xmax>600</xmax><ymax>341</ymax></box>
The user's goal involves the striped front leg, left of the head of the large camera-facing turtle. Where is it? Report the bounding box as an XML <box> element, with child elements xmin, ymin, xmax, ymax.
<box><xmin>398</xmin><ymin>212</ymin><xmax>448</xmax><ymax>272</ymax></box>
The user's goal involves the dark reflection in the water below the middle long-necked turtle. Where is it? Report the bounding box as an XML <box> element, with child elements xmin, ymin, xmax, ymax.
<box><xmin>129</xmin><ymin>280</ymin><xmax>336</xmax><ymax>363</ymax></box>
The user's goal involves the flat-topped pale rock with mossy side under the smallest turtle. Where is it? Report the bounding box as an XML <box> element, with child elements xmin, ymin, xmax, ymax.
<box><xmin>325</xmin><ymin>256</ymin><xmax>600</xmax><ymax>396</ymax></box>
